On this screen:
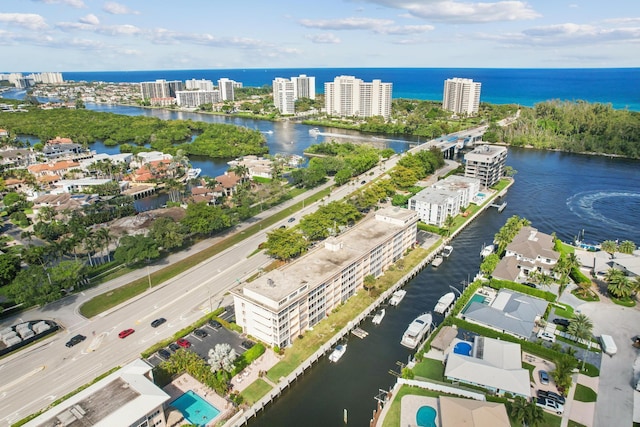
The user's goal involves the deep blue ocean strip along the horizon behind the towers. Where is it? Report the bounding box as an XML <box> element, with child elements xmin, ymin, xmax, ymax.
<box><xmin>52</xmin><ymin>68</ymin><xmax>640</xmax><ymax>111</ymax></box>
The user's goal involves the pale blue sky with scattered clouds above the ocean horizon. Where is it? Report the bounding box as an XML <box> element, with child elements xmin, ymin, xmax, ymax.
<box><xmin>0</xmin><ymin>0</ymin><xmax>640</xmax><ymax>71</ymax></box>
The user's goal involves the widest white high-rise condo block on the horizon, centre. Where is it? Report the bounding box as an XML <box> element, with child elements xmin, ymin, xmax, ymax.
<box><xmin>324</xmin><ymin>76</ymin><xmax>393</xmax><ymax>119</ymax></box>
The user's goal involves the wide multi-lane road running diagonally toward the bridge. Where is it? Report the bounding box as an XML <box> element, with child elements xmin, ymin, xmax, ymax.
<box><xmin>0</xmin><ymin>131</ymin><xmax>471</xmax><ymax>425</ymax></box>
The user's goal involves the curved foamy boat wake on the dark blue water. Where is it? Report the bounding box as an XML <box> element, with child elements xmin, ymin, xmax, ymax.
<box><xmin>567</xmin><ymin>190</ymin><xmax>640</xmax><ymax>230</ymax></box>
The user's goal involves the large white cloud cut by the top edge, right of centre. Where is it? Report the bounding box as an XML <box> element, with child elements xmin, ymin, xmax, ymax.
<box><xmin>366</xmin><ymin>0</ymin><xmax>541</xmax><ymax>23</ymax></box>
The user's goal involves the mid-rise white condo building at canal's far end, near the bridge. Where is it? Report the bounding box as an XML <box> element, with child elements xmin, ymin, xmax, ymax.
<box><xmin>464</xmin><ymin>145</ymin><xmax>507</xmax><ymax>187</ymax></box>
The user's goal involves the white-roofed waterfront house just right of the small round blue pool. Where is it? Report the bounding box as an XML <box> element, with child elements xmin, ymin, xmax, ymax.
<box><xmin>444</xmin><ymin>336</ymin><xmax>531</xmax><ymax>400</ymax></box>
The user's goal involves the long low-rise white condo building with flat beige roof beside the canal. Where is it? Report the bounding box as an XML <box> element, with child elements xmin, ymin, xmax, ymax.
<box><xmin>231</xmin><ymin>207</ymin><xmax>418</xmax><ymax>348</ymax></box>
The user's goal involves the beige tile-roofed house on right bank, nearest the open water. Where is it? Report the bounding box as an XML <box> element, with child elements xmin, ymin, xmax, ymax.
<box><xmin>492</xmin><ymin>226</ymin><xmax>560</xmax><ymax>282</ymax></box>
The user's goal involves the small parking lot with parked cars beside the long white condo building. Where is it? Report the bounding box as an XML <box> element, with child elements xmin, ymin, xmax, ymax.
<box><xmin>147</xmin><ymin>307</ymin><xmax>254</xmax><ymax>366</ymax></box>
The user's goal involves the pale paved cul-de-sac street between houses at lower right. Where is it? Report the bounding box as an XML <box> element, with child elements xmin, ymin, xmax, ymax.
<box><xmin>576</xmin><ymin>297</ymin><xmax>640</xmax><ymax>427</ymax></box>
